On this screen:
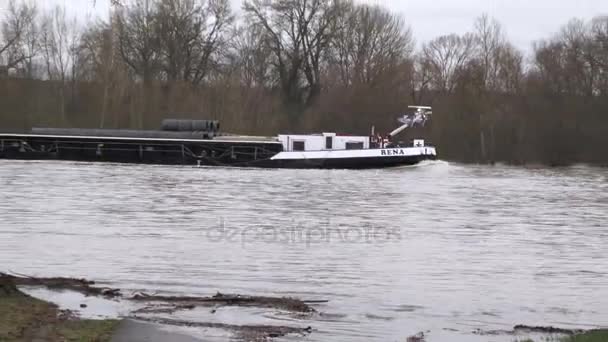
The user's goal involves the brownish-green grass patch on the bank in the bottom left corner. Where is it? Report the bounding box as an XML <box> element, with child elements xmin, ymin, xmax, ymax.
<box><xmin>0</xmin><ymin>284</ymin><xmax>119</xmax><ymax>342</ymax></box>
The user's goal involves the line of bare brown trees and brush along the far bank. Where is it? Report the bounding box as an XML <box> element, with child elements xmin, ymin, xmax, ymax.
<box><xmin>0</xmin><ymin>0</ymin><xmax>608</xmax><ymax>165</ymax></box>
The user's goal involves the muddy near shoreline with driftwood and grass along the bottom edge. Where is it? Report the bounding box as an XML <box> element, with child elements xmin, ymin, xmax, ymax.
<box><xmin>0</xmin><ymin>272</ymin><xmax>608</xmax><ymax>342</ymax></box>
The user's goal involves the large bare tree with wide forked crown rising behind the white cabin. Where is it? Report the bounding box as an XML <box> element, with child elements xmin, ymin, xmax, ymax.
<box><xmin>243</xmin><ymin>0</ymin><xmax>343</xmax><ymax>105</ymax></box>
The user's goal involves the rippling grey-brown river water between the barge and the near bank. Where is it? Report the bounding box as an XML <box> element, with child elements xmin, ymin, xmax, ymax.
<box><xmin>0</xmin><ymin>161</ymin><xmax>608</xmax><ymax>342</ymax></box>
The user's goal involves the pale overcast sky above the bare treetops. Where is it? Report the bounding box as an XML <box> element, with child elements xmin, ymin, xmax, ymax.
<box><xmin>0</xmin><ymin>0</ymin><xmax>608</xmax><ymax>51</ymax></box>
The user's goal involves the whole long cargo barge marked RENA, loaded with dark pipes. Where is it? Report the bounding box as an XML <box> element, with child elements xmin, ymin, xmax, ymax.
<box><xmin>0</xmin><ymin>106</ymin><xmax>437</xmax><ymax>169</ymax></box>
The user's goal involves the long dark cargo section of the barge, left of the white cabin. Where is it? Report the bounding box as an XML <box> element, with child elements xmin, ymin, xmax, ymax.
<box><xmin>0</xmin><ymin>134</ymin><xmax>283</xmax><ymax>166</ymax></box>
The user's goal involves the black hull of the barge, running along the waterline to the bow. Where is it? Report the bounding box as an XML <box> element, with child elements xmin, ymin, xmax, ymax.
<box><xmin>0</xmin><ymin>134</ymin><xmax>435</xmax><ymax>169</ymax></box>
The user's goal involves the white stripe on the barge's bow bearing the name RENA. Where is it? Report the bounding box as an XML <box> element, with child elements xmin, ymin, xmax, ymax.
<box><xmin>271</xmin><ymin>147</ymin><xmax>436</xmax><ymax>160</ymax></box>
